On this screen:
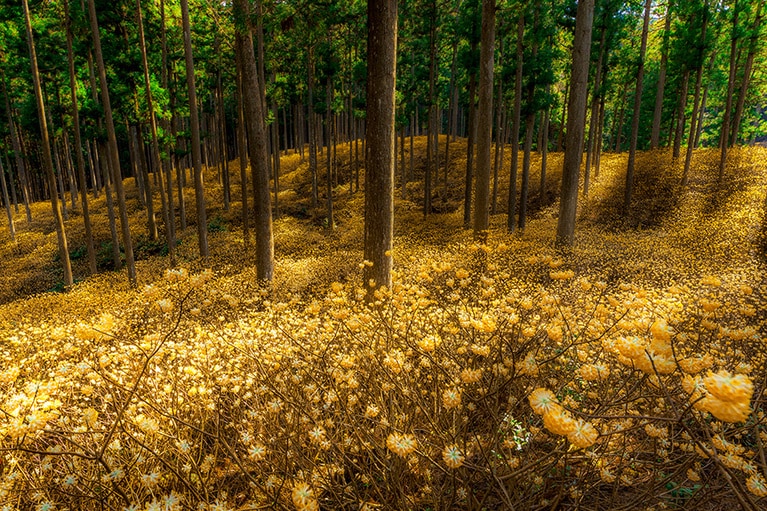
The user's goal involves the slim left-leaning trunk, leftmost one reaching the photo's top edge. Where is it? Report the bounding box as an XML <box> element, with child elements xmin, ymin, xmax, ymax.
<box><xmin>22</xmin><ymin>0</ymin><xmax>73</xmax><ymax>289</ymax></box>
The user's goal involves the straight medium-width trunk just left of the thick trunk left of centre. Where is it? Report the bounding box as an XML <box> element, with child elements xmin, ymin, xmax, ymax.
<box><xmin>182</xmin><ymin>0</ymin><xmax>208</xmax><ymax>259</ymax></box>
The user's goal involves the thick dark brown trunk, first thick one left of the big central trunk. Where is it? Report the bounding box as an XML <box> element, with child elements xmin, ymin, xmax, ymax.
<box><xmin>234</xmin><ymin>0</ymin><xmax>274</xmax><ymax>282</ymax></box>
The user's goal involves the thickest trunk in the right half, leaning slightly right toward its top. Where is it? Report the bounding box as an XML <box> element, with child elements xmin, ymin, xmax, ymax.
<box><xmin>556</xmin><ymin>0</ymin><xmax>594</xmax><ymax>247</ymax></box>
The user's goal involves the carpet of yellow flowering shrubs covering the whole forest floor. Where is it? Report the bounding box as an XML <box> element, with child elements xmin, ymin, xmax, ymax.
<box><xmin>0</xmin><ymin>140</ymin><xmax>767</xmax><ymax>511</ymax></box>
